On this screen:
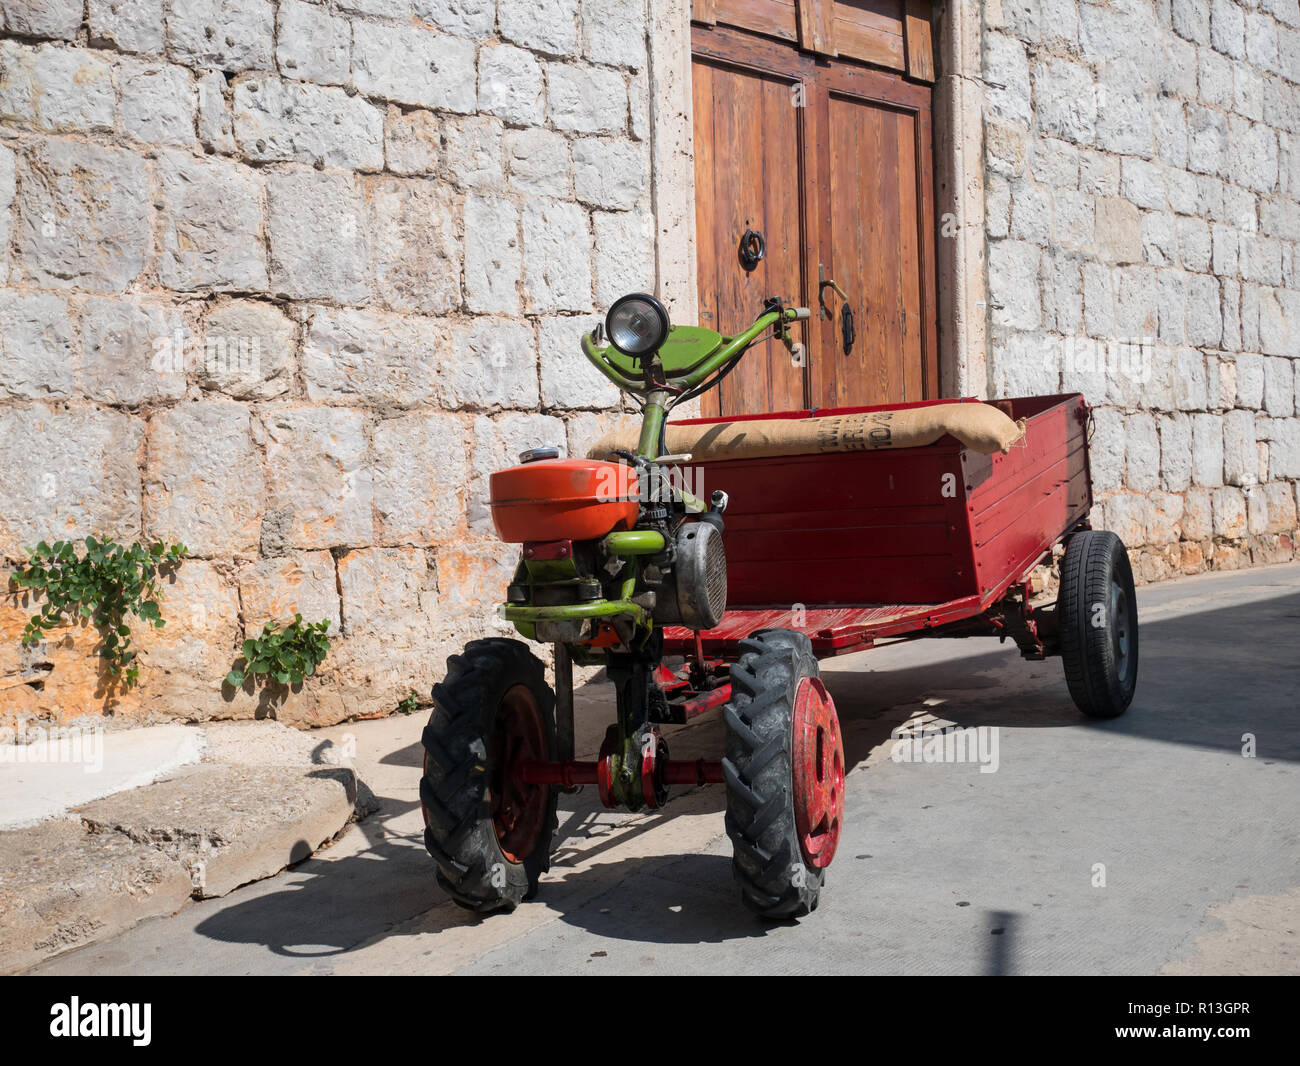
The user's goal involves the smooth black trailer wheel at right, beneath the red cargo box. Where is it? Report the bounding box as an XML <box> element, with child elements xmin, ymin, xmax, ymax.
<box><xmin>1057</xmin><ymin>529</ymin><xmax>1138</xmax><ymax>718</ymax></box>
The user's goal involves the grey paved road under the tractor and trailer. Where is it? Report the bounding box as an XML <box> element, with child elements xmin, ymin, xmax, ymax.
<box><xmin>38</xmin><ymin>566</ymin><xmax>1300</xmax><ymax>975</ymax></box>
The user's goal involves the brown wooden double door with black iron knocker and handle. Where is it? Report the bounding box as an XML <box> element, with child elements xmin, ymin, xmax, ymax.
<box><xmin>693</xmin><ymin>0</ymin><xmax>939</xmax><ymax>415</ymax></box>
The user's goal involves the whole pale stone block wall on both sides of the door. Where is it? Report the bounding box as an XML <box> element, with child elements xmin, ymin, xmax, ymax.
<box><xmin>10</xmin><ymin>0</ymin><xmax>1300</xmax><ymax>724</ymax></box>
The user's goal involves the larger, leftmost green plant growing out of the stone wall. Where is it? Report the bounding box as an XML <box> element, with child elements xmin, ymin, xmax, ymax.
<box><xmin>10</xmin><ymin>537</ymin><xmax>189</xmax><ymax>688</ymax></box>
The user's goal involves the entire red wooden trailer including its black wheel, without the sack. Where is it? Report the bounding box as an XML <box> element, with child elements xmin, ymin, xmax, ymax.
<box><xmin>659</xmin><ymin>394</ymin><xmax>1138</xmax><ymax>720</ymax></box>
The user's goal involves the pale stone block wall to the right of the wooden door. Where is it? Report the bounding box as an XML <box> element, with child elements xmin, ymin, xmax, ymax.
<box><xmin>983</xmin><ymin>0</ymin><xmax>1300</xmax><ymax>580</ymax></box>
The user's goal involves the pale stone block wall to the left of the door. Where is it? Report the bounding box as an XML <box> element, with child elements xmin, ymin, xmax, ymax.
<box><xmin>0</xmin><ymin>0</ymin><xmax>655</xmax><ymax>723</ymax></box>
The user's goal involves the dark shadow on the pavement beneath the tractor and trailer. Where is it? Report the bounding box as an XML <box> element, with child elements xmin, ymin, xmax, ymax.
<box><xmin>196</xmin><ymin>595</ymin><xmax>1300</xmax><ymax>972</ymax></box>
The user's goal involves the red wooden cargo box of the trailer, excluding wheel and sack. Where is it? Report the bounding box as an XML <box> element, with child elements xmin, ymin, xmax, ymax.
<box><xmin>664</xmin><ymin>394</ymin><xmax>1092</xmax><ymax>658</ymax></box>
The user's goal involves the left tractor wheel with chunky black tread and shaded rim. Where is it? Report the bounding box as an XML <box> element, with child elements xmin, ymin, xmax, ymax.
<box><xmin>420</xmin><ymin>637</ymin><xmax>558</xmax><ymax>914</ymax></box>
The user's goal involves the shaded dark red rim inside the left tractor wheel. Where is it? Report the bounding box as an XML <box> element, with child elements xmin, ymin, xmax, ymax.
<box><xmin>488</xmin><ymin>685</ymin><xmax>550</xmax><ymax>862</ymax></box>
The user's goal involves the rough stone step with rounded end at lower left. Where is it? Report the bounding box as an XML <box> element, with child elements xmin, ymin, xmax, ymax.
<box><xmin>0</xmin><ymin>722</ymin><xmax>369</xmax><ymax>972</ymax></box>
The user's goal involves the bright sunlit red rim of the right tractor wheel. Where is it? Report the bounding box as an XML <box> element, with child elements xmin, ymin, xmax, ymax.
<box><xmin>793</xmin><ymin>677</ymin><xmax>844</xmax><ymax>870</ymax></box>
